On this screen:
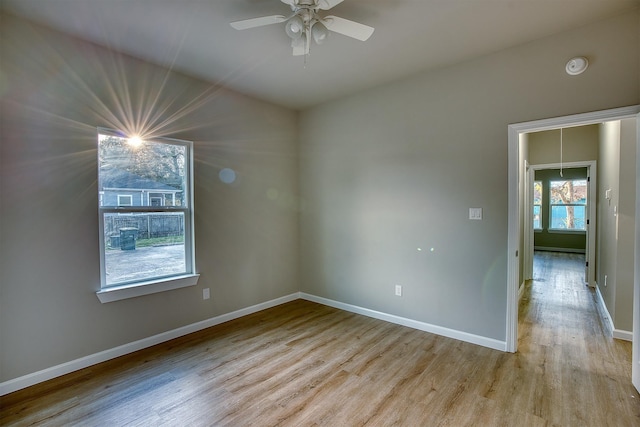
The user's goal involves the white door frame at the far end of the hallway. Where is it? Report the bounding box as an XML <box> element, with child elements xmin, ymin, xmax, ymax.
<box><xmin>522</xmin><ymin>160</ymin><xmax>598</xmax><ymax>288</ymax></box>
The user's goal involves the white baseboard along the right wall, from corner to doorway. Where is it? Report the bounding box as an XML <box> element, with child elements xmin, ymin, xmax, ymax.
<box><xmin>300</xmin><ymin>292</ymin><xmax>506</xmax><ymax>351</ymax></box>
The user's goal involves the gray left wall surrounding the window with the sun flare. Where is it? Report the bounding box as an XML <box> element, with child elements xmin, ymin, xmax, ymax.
<box><xmin>0</xmin><ymin>16</ymin><xmax>298</xmax><ymax>381</ymax></box>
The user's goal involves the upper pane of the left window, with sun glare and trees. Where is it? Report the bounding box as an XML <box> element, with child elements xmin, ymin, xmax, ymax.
<box><xmin>98</xmin><ymin>135</ymin><xmax>187</xmax><ymax>207</ymax></box>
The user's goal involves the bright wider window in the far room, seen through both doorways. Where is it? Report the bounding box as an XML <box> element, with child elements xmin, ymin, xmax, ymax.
<box><xmin>549</xmin><ymin>179</ymin><xmax>587</xmax><ymax>231</ymax></box>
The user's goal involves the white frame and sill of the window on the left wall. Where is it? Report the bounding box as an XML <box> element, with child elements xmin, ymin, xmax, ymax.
<box><xmin>96</xmin><ymin>128</ymin><xmax>200</xmax><ymax>303</ymax></box>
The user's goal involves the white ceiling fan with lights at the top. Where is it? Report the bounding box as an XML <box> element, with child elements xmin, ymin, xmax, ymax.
<box><xmin>231</xmin><ymin>0</ymin><xmax>374</xmax><ymax>56</ymax></box>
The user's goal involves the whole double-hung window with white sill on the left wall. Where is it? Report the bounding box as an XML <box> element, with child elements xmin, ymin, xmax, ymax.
<box><xmin>98</xmin><ymin>129</ymin><xmax>197</xmax><ymax>302</ymax></box>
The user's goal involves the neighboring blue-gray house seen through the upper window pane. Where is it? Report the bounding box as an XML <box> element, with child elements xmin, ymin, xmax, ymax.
<box><xmin>100</xmin><ymin>169</ymin><xmax>182</xmax><ymax>206</ymax></box>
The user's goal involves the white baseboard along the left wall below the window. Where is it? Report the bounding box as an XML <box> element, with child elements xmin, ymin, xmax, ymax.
<box><xmin>0</xmin><ymin>293</ymin><xmax>300</xmax><ymax>396</ymax></box>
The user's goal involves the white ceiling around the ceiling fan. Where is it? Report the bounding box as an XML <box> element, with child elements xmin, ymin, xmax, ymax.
<box><xmin>1</xmin><ymin>0</ymin><xmax>640</xmax><ymax>109</ymax></box>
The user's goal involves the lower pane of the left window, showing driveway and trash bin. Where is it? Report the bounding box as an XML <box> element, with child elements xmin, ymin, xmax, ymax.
<box><xmin>104</xmin><ymin>212</ymin><xmax>186</xmax><ymax>286</ymax></box>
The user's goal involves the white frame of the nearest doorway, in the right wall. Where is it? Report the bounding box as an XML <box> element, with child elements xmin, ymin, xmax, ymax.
<box><xmin>506</xmin><ymin>105</ymin><xmax>640</xmax><ymax>354</ymax></box>
